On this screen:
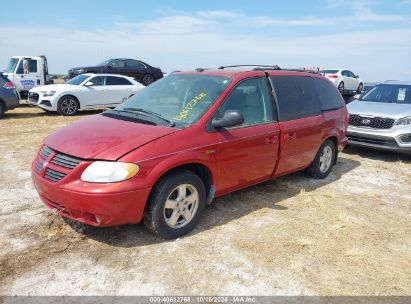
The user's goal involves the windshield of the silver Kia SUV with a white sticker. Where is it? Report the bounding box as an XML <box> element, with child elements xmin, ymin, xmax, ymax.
<box><xmin>360</xmin><ymin>84</ymin><xmax>411</xmax><ymax>104</ymax></box>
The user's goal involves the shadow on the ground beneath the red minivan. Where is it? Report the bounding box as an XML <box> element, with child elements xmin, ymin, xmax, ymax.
<box><xmin>66</xmin><ymin>157</ymin><xmax>360</xmax><ymax>248</ymax></box>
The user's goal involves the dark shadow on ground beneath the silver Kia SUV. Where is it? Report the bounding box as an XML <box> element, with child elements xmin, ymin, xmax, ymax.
<box><xmin>344</xmin><ymin>146</ymin><xmax>411</xmax><ymax>164</ymax></box>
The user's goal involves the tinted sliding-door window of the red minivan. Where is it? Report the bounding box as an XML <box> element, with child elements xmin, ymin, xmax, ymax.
<box><xmin>271</xmin><ymin>76</ymin><xmax>321</xmax><ymax>121</ymax></box>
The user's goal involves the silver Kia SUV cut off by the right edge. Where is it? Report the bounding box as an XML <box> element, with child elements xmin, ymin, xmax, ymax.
<box><xmin>347</xmin><ymin>81</ymin><xmax>411</xmax><ymax>154</ymax></box>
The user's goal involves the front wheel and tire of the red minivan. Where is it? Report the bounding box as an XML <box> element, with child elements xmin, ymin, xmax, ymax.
<box><xmin>144</xmin><ymin>170</ymin><xmax>206</xmax><ymax>239</ymax></box>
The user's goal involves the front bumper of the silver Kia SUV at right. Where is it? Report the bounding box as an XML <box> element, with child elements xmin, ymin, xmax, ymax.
<box><xmin>347</xmin><ymin>126</ymin><xmax>411</xmax><ymax>154</ymax></box>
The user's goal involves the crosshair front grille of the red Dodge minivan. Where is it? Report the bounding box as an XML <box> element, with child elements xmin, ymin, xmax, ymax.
<box><xmin>34</xmin><ymin>146</ymin><xmax>83</xmax><ymax>182</ymax></box>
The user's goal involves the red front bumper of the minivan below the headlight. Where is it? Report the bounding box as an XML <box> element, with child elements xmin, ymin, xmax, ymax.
<box><xmin>32</xmin><ymin>159</ymin><xmax>150</xmax><ymax>227</ymax></box>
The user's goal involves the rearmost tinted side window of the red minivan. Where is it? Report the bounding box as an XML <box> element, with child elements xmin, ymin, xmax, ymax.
<box><xmin>310</xmin><ymin>78</ymin><xmax>344</xmax><ymax>111</ymax></box>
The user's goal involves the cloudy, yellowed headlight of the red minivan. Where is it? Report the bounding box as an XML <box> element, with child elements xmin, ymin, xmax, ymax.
<box><xmin>81</xmin><ymin>161</ymin><xmax>140</xmax><ymax>183</ymax></box>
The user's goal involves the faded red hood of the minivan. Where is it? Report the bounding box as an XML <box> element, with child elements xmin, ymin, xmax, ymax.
<box><xmin>44</xmin><ymin>115</ymin><xmax>177</xmax><ymax>160</ymax></box>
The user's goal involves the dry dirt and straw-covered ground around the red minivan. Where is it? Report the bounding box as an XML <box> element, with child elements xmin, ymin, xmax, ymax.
<box><xmin>0</xmin><ymin>107</ymin><xmax>411</xmax><ymax>295</ymax></box>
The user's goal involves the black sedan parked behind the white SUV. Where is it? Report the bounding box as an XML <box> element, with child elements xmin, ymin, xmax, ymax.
<box><xmin>68</xmin><ymin>58</ymin><xmax>163</xmax><ymax>86</ymax></box>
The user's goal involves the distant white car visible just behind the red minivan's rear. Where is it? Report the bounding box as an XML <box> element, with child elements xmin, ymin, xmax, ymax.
<box><xmin>321</xmin><ymin>69</ymin><xmax>364</xmax><ymax>94</ymax></box>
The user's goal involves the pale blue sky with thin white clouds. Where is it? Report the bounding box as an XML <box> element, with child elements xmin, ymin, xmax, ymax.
<box><xmin>0</xmin><ymin>0</ymin><xmax>411</xmax><ymax>81</ymax></box>
